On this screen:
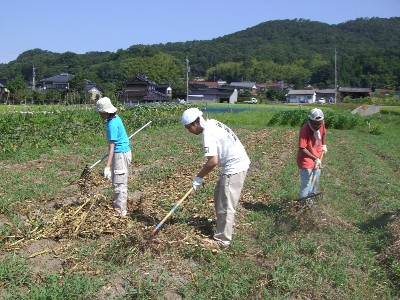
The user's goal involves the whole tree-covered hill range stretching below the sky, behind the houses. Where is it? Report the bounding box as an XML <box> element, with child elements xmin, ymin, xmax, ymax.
<box><xmin>0</xmin><ymin>17</ymin><xmax>400</xmax><ymax>89</ymax></box>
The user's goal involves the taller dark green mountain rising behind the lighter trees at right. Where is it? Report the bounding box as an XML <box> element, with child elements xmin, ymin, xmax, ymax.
<box><xmin>153</xmin><ymin>18</ymin><xmax>400</xmax><ymax>71</ymax></box>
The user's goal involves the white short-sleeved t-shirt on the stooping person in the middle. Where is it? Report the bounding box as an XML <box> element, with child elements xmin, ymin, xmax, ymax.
<box><xmin>202</xmin><ymin>119</ymin><xmax>250</xmax><ymax>175</ymax></box>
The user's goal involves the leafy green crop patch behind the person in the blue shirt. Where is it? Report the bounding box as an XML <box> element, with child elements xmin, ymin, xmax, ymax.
<box><xmin>0</xmin><ymin>105</ymin><xmax>187</xmax><ymax>159</ymax></box>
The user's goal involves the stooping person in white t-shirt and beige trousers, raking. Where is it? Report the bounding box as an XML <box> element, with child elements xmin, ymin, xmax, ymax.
<box><xmin>182</xmin><ymin>107</ymin><xmax>250</xmax><ymax>248</ymax></box>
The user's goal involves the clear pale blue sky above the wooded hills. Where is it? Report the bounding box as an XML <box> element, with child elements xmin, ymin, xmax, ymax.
<box><xmin>0</xmin><ymin>0</ymin><xmax>400</xmax><ymax>63</ymax></box>
